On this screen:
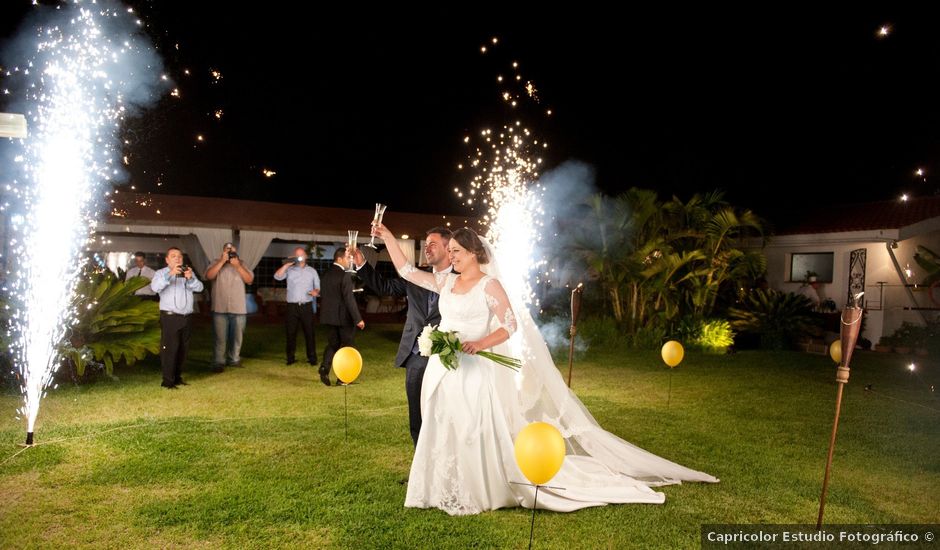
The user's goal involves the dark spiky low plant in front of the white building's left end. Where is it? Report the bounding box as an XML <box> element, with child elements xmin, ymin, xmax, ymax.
<box><xmin>728</xmin><ymin>289</ymin><xmax>817</xmax><ymax>349</ymax></box>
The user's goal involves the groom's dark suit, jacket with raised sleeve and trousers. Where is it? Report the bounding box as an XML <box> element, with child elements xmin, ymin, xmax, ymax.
<box><xmin>359</xmin><ymin>262</ymin><xmax>452</xmax><ymax>445</ymax></box>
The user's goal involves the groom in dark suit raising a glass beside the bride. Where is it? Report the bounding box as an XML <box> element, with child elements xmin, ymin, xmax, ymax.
<box><xmin>354</xmin><ymin>227</ymin><xmax>453</xmax><ymax>445</ymax></box>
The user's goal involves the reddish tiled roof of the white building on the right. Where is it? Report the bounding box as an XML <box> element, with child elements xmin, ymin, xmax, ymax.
<box><xmin>775</xmin><ymin>196</ymin><xmax>940</xmax><ymax>235</ymax></box>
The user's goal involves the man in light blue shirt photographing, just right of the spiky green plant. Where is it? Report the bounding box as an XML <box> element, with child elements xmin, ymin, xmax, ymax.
<box><xmin>150</xmin><ymin>246</ymin><xmax>203</xmax><ymax>390</ymax></box>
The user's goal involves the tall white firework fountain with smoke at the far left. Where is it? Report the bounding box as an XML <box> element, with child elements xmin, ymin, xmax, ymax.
<box><xmin>3</xmin><ymin>3</ymin><xmax>163</xmax><ymax>441</ymax></box>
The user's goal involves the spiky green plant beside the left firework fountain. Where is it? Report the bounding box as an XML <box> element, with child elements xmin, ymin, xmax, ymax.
<box><xmin>60</xmin><ymin>270</ymin><xmax>160</xmax><ymax>377</ymax></box>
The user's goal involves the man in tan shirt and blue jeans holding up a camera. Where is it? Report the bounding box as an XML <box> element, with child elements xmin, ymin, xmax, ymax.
<box><xmin>206</xmin><ymin>243</ymin><xmax>255</xmax><ymax>372</ymax></box>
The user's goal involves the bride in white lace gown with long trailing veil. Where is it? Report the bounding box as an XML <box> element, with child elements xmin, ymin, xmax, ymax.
<box><xmin>374</xmin><ymin>224</ymin><xmax>718</xmax><ymax>515</ymax></box>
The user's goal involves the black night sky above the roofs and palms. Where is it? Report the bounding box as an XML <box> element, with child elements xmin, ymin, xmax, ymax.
<box><xmin>0</xmin><ymin>0</ymin><xmax>940</xmax><ymax>227</ymax></box>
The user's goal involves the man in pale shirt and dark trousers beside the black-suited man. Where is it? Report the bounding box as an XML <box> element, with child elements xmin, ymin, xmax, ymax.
<box><xmin>274</xmin><ymin>246</ymin><xmax>320</xmax><ymax>365</ymax></box>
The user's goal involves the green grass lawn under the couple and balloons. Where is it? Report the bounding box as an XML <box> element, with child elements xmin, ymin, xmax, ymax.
<box><xmin>0</xmin><ymin>324</ymin><xmax>940</xmax><ymax>548</ymax></box>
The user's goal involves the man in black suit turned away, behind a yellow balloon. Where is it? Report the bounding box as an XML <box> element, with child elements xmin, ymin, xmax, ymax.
<box><xmin>320</xmin><ymin>248</ymin><xmax>366</xmax><ymax>386</ymax></box>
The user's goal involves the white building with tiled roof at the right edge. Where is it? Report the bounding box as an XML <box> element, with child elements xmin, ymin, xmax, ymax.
<box><xmin>764</xmin><ymin>197</ymin><xmax>940</xmax><ymax>344</ymax></box>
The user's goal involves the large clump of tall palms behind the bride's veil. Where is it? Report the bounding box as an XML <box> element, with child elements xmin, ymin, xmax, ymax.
<box><xmin>568</xmin><ymin>188</ymin><xmax>766</xmax><ymax>339</ymax></box>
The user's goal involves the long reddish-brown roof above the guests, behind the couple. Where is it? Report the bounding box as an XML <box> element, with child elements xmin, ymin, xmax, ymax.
<box><xmin>105</xmin><ymin>193</ymin><xmax>476</xmax><ymax>239</ymax></box>
